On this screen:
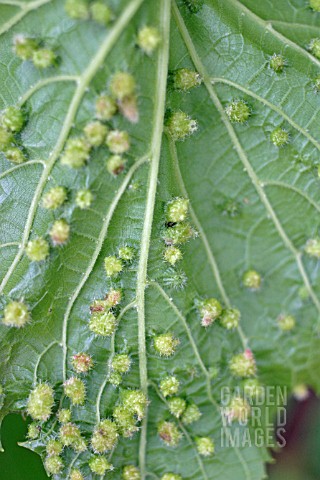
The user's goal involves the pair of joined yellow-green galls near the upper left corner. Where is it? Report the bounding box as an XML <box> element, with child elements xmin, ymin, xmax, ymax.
<box><xmin>14</xmin><ymin>35</ymin><xmax>57</xmax><ymax>69</ymax></box>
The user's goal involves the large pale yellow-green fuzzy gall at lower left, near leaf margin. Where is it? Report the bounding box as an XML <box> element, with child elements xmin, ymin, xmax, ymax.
<box><xmin>27</xmin><ymin>383</ymin><xmax>54</xmax><ymax>421</ymax></box>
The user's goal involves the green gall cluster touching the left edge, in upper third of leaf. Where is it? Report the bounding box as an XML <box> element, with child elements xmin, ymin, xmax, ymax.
<box><xmin>0</xmin><ymin>106</ymin><xmax>26</xmax><ymax>164</ymax></box>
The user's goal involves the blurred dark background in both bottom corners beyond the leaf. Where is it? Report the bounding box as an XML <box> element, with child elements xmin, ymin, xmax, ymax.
<box><xmin>0</xmin><ymin>395</ymin><xmax>320</xmax><ymax>480</ymax></box>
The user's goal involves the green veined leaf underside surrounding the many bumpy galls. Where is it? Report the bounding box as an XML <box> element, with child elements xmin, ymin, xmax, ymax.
<box><xmin>0</xmin><ymin>0</ymin><xmax>320</xmax><ymax>480</ymax></box>
